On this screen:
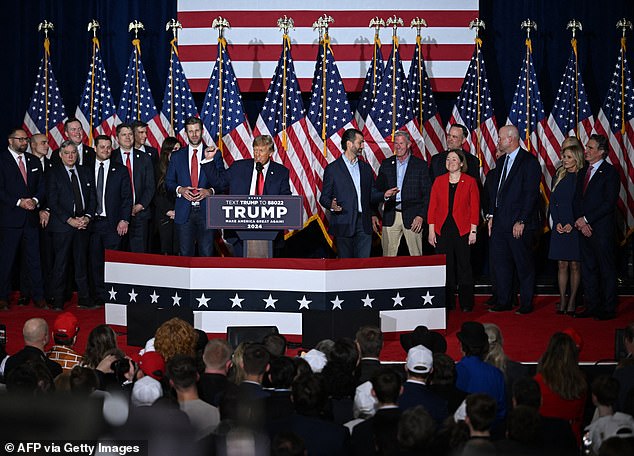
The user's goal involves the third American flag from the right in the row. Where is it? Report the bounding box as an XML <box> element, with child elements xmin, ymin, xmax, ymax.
<box><xmin>507</xmin><ymin>39</ymin><xmax>559</xmax><ymax>198</ymax></box>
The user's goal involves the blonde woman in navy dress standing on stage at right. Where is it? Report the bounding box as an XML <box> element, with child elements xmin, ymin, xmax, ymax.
<box><xmin>548</xmin><ymin>137</ymin><xmax>583</xmax><ymax>315</ymax></box>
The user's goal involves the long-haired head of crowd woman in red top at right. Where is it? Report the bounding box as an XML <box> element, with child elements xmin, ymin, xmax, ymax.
<box><xmin>537</xmin><ymin>332</ymin><xmax>587</xmax><ymax>400</ymax></box>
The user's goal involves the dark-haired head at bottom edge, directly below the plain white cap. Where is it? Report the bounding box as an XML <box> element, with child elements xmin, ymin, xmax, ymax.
<box><xmin>396</xmin><ymin>405</ymin><xmax>436</xmax><ymax>454</ymax></box>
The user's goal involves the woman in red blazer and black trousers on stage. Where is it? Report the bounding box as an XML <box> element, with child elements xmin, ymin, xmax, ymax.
<box><xmin>427</xmin><ymin>149</ymin><xmax>480</xmax><ymax>312</ymax></box>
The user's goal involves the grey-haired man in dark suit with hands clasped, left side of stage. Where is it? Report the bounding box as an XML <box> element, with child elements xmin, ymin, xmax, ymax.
<box><xmin>46</xmin><ymin>140</ymin><xmax>95</xmax><ymax>310</ymax></box>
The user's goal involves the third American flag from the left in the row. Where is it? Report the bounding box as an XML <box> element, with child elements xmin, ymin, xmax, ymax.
<box><xmin>117</xmin><ymin>39</ymin><xmax>169</xmax><ymax>150</ymax></box>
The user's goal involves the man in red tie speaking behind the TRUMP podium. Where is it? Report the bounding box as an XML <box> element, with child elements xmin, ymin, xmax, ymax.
<box><xmin>204</xmin><ymin>135</ymin><xmax>291</xmax><ymax>256</ymax></box>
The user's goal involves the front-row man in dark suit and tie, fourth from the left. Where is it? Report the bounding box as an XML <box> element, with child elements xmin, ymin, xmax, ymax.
<box><xmin>110</xmin><ymin>123</ymin><xmax>156</xmax><ymax>253</ymax></box>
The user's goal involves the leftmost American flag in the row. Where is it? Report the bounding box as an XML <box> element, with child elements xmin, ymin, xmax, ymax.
<box><xmin>22</xmin><ymin>38</ymin><xmax>66</xmax><ymax>149</ymax></box>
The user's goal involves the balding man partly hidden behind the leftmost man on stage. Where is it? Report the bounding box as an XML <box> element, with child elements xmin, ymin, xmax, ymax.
<box><xmin>18</xmin><ymin>133</ymin><xmax>52</xmax><ymax>306</ymax></box>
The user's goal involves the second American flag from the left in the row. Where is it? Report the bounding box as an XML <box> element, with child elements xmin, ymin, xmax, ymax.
<box><xmin>75</xmin><ymin>37</ymin><xmax>117</xmax><ymax>146</ymax></box>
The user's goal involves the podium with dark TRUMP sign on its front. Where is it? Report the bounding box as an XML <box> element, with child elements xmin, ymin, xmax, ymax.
<box><xmin>202</xmin><ymin>195</ymin><xmax>303</xmax><ymax>258</ymax></box>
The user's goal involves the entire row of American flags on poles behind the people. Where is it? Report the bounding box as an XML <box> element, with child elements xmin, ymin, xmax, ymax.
<box><xmin>24</xmin><ymin>19</ymin><xmax>634</xmax><ymax>234</ymax></box>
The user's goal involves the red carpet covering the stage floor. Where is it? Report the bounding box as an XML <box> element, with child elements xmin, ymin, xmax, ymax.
<box><xmin>0</xmin><ymin>296</ymin><xmax>634</xmax><ymax>362</ymax></box>
